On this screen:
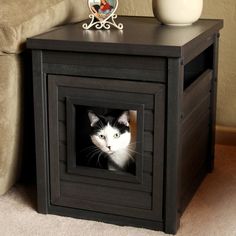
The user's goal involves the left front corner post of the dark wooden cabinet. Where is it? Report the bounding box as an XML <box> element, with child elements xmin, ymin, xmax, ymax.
<box><xmin>32</xmin><ymin>50</ymin><xmax>49</xmax><ymax>213</ymax></box>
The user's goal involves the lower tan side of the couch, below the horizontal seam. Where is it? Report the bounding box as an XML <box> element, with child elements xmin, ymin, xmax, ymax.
<box><xmin>0</xmin><ymin>54</ymin><xmax>23</xmax><ymax>195</ymax></box>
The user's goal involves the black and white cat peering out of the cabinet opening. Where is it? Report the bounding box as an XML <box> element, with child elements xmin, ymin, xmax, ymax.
<box><xmin>88</xmin><ymin>110</ymin><xmax>135</xmax><ymax>173</ymax></box>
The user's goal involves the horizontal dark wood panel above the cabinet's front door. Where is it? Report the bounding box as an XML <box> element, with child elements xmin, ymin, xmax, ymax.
<box><xmin>44</xmin><ymin>51</ymin><xmax>166</xmax><ymax>83</ymax></box>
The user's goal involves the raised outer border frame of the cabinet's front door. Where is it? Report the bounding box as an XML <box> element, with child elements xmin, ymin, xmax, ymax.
<box><xmin>47</xmin><ymin>75</ymin><xmax>165</xmax><ymax>221</ymax></box>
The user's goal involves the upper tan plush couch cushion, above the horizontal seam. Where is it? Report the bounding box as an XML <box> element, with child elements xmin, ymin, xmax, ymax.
<box><xmin>0</xmin><ymin>0</ymin><xmax>88</xmax><ymax>55</ymax></box>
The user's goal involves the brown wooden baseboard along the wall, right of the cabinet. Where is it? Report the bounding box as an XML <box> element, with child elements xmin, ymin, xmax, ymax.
<box><xmin>216</xmin><ymin>125</ymin><xmax>236</xmax><ymax>146</ymax></box>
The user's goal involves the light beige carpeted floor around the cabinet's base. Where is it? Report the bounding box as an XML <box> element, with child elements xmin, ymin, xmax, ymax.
<box><xmin>0</xmin><ymin>145</ymin><xmax>236</xmax><ymax>236</ymax></box>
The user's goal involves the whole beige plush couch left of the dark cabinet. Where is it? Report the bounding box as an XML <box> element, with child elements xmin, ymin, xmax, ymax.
<box><xmin>0</xmin><ymin>0</ymin><xmax>88</xmax><ymax>194</ymax></box>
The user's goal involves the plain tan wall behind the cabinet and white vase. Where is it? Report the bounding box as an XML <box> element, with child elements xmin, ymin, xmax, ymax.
<box><xmin>118</xmin><ymin>0</ymin><xmax>236</xmax><ymax>127</ymax></box>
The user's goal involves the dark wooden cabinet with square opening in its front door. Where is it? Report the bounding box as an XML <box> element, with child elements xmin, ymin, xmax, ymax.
<box><xmin>27</xmin><ymin>17</ymin><xmax>223</xmax><ymax>233</ymax></box>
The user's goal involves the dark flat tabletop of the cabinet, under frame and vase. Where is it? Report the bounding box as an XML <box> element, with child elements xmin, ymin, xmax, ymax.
<box><xmin>27</xmin><ymin>17</ymin><xmax>223</xmax><ymax>57</ymax></box>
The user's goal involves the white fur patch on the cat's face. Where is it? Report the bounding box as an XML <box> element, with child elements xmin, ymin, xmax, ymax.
<box><xmin>91</xmin><ymin>123</ymin><xmax>131</xmax><ymax>155</ymax></box>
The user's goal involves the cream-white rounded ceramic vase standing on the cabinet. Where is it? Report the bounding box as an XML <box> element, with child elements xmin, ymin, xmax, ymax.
<box><xmin>152</xmin><ymin>0</ymin><xmax>203</xmax><ymax>26</ymax></box>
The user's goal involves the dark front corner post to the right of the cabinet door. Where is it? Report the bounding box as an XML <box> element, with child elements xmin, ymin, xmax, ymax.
<box><xmin>164</xmin><ymin>58</ymin><xmax>184</xmax><ymax>233</ymax></box>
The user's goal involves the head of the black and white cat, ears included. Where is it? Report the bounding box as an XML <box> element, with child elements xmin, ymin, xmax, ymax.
<box><xmin>88</xmin><ymin>111</ymin><xmax>131</xmax><ymax>155</ymax></box>
